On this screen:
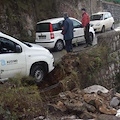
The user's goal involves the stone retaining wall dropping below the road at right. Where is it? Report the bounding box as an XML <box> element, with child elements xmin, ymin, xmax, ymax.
<box><xmin>98</xmin><ymin>31</ymin><xmax>120</xmax><ymax>88</ymax></box>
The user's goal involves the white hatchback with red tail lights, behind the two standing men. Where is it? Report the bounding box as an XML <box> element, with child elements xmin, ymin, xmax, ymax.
<box><xmin>35</xmin><ymin>17</ymin><xmax>95</xmax><ymax>51</ymax></box>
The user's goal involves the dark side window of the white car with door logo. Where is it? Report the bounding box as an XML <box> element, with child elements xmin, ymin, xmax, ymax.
<box><xmin>0</xmin><ymin>37</ymin><xmax>17</xmax><ymax>54</ymax></box>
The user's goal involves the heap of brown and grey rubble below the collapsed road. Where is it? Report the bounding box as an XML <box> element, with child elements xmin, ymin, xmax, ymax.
<box><xmin>48</xmin><ymin>85</ymin><xmax>120</xmax><ymax>120</ymax></box>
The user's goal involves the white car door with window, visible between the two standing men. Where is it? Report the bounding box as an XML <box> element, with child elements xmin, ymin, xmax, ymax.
<box><xmin>72</xmin><ymin>20</ymin><xmax>84</xmax><ymax>43</ymax></box>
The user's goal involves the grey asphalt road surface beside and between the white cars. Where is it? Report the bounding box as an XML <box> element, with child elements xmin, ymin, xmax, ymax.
<box><xmin>51</xmin><ymin>23</ymin><xmax>120</xmax><ymax>62</ymax></box>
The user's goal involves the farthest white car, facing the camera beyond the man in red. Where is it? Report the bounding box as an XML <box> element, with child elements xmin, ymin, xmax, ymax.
<box><xmin>90</xmin><ymin>12</ymin><xmax>114</xmax><ymax>33</ymax></box>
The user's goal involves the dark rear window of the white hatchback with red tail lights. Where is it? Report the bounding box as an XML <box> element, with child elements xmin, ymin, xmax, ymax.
<box><xmin>36</xmin><ymin>23</ymin><xmax>50</xmax><ymax>32</ymax></box>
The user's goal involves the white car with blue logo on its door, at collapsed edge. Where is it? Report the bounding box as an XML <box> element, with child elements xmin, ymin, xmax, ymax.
<box><xmin>0</xmin><ymin>32</ymin><xmax>54</xmax><ymax>82</ymax></box>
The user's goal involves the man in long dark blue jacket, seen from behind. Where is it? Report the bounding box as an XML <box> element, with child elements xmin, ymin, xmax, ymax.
<box><xmin>62</xmin><ymin>13</ymin><xmax>74</xmax><ymax>52</ymax></box>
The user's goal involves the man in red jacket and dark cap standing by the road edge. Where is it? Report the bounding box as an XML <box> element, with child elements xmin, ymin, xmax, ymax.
<box><xmin>81</xmin><ymin>8</ymin><xmax>92</xmax><ymax>47</ymax></box>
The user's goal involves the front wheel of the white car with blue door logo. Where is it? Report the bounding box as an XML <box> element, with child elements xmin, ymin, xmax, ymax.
<box><xmin>31</xmin><ymin>65</ymin><xmax>45</xmax><ymax>83</ymax></box>
